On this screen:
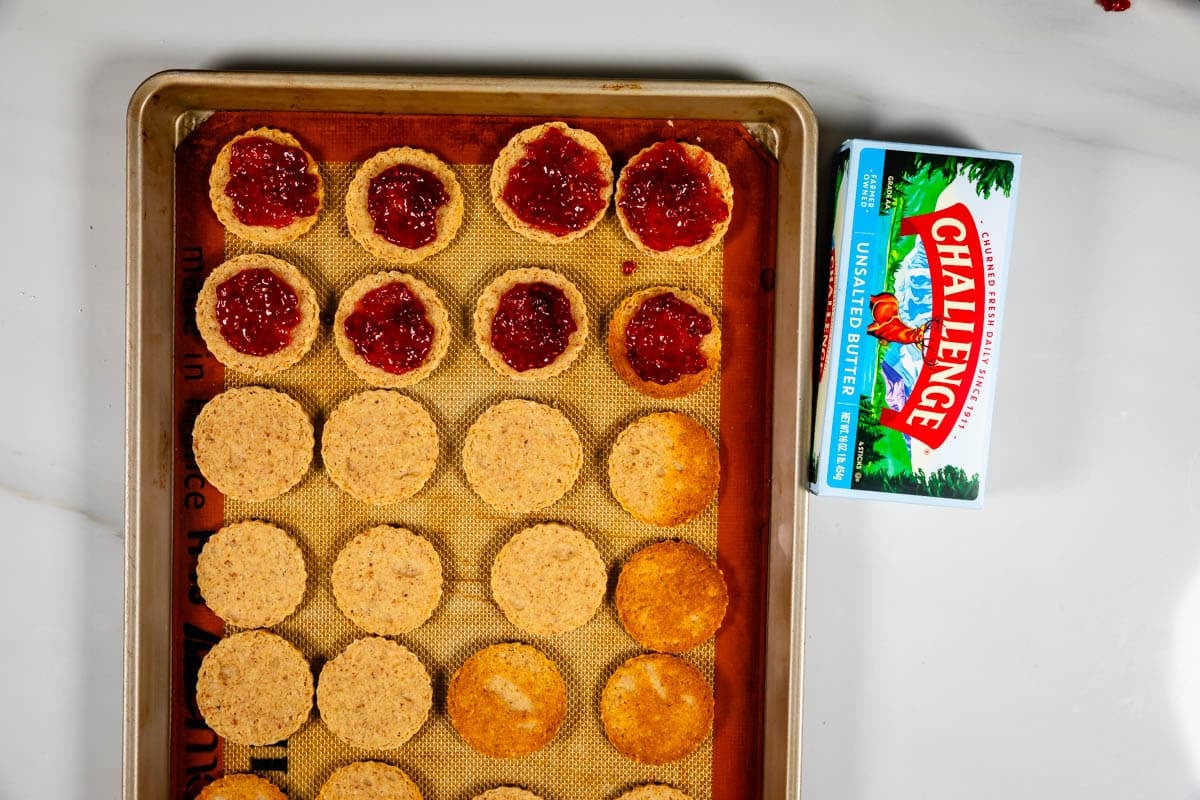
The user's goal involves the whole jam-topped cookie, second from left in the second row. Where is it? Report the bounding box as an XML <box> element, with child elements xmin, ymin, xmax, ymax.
<box><xmin>334</xmin><ymin>272</ymin><xmax>450</xmax><ymax>389</ymax></box>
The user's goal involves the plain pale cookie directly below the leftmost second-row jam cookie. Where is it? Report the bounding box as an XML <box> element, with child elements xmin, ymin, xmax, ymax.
<box><xmin>192</xmin><ymin>386</ymin><xmax>313</xmax><ymax>500</ymax></box>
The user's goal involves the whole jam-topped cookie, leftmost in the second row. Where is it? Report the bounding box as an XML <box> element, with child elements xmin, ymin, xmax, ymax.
<box><xmin>196</xmin><ymin>253</ymin><xmax>320</xmax><ymax>375</ymax></box>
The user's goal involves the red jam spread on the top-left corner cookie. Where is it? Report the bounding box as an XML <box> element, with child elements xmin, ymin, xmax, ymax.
<box><xmin>224</xmin><ymin>136</ymin><xmax>319</xmax><ymax>228</ymax></box>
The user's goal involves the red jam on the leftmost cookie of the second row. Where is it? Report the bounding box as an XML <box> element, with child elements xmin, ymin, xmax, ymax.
<box><xmin>217</xmin><ymin>269</ymin><xmax>300</xmax><ymax>356</ymax></box>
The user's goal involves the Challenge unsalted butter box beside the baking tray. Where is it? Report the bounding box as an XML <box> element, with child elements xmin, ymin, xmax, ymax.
<box><xmin>810</xmin><ymin>139</ymin><xmax>1020</xmax><ymax>507</ymax></box>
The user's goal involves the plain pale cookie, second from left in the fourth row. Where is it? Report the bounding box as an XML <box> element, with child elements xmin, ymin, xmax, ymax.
<box><xmin>330</xmin><ymin>525</ymin><xmax>442</xmax><ymax>636</ymax></box>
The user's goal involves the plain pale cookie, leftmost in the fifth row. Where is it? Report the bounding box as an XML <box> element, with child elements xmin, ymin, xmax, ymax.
<box><xmin>196</xmin><ymin>631</ymin><xmax>312</xmax><ymax>745</ymax></box>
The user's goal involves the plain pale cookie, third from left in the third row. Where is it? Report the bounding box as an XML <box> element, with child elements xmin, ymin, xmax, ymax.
<box><xmin>462</xmin><ymin>399</ymin><xmax>583</xmax><ymax>513</ymax></box>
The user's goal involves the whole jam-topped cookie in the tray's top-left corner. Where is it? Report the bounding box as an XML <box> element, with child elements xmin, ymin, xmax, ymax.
<box><xmin>209</xmin><ymin>128</ymin><xmax>325</xmax><ymax>245</ymax></box>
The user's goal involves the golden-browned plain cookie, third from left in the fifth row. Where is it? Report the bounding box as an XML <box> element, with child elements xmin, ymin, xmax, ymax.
<box><xmin>446</xmin><ymin>643</ymin><xmax>566</xmax><ymax>758</ymax></box>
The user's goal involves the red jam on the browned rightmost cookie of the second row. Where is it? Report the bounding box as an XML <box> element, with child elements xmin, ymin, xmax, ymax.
<box><xmin>625</xmin><ymin>291</ymin><xmax>713</xmax><ymax>385</ymax></box>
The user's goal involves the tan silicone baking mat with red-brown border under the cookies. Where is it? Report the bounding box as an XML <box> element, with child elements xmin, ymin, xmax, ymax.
<box><xmin>172</xmin><ymin>112</ymin><xmax>775</xmax><ymax>800</ymax></box>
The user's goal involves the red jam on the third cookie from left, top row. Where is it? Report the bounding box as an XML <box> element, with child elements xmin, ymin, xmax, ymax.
<box><xmin>500</xmin><ymin>127</ymin><xmax>608</xmax><ymax>236</ymax></box>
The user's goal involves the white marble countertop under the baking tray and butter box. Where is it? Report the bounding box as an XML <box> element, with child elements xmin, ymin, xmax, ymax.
<box><xmin>0</xmin><ymin>0</ymin><xmax>1200</xmax><ymax>800</ymax></box>
